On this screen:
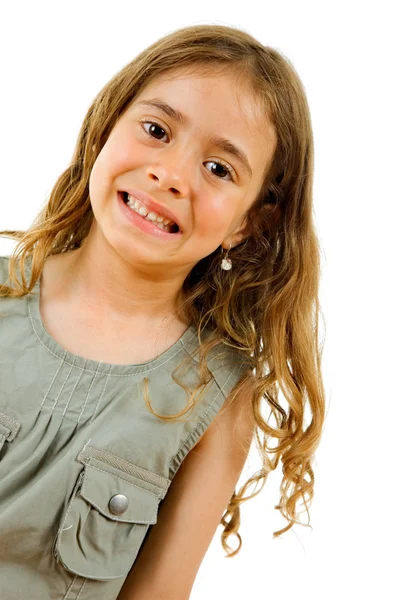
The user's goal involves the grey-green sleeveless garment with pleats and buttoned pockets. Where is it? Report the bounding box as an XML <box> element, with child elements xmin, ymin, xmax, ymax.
<box><xmin>0</xmin><ymin>256</ymin><xmax>247</xmax><ymax>600</ymax></box>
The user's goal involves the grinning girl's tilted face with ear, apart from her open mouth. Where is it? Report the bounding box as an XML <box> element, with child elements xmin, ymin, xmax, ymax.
<box><xmin>89</xmin><ymin>70</ymin><xmax>276</xmax><ymax>274</ymax></box>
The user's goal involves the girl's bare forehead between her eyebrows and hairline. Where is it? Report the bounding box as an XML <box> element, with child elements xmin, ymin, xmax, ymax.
<box><xmin>132</xmin><ymin>68</ymin><xmax>276</xmax><ymax>179</ymax></box>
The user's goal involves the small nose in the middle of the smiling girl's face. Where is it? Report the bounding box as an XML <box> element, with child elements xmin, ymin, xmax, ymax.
<box><xmin>147</xmin><ymin>150</ymin><xmax>190</xmax><ymax>197</ymax></box>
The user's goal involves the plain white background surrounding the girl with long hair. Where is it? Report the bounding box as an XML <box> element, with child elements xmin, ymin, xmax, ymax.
<box><xmin>0</xmin><ymin>0</ymin><xmax>400</xmax><ymax>600</ymax></box>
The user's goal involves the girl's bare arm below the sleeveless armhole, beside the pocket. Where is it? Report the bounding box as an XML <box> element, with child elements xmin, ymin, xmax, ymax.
<box><xmin>118</xmin><ymin>376</ymin><xmax>255</xmax><ymax>600</ymax></box>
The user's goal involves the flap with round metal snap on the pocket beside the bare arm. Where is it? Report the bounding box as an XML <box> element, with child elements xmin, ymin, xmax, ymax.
<box><xmin>80</xmin><ymin>463</ymin><xmax>160</xmax><ymax>524</ymax></box>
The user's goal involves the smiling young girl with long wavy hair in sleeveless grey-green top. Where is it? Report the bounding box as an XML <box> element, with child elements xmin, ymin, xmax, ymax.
<box><xmin>0</xmin><ymin>25</ymin><xmax>325</xmax><ymax>600</ymax></box>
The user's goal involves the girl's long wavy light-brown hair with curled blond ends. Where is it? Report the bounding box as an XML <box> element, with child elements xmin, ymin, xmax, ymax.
<box><xmin>0</xmin><ymin>25</ymin><xmax>325</xmax><ymax>556</ymax></box>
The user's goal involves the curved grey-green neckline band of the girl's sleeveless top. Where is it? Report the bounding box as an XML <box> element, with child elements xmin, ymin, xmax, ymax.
<box><xmin>27</xmin><ymin>261</ymin><xmax>197</xmax><ymax>375</ymax></box>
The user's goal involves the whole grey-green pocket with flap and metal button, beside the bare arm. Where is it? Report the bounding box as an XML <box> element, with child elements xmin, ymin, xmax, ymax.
<box><xmin>54</xmin><ymin>447</ymin><xmax>170</xmax><ymax>580</ymax></box>
